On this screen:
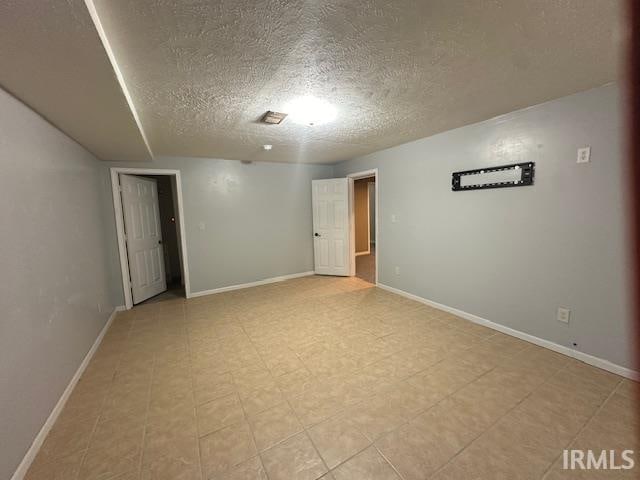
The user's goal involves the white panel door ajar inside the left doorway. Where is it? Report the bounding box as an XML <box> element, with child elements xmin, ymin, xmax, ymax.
<box><xmin>120</xmin><ymin>174</ymin><xmax>167</xmax><ymax>305</ymax></box>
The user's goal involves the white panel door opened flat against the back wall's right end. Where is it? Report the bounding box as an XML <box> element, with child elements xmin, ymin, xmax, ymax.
<box><xmin>312</xmin><ymin>178</ymin><xmax>352</xmax><ymax>276</ymax></box>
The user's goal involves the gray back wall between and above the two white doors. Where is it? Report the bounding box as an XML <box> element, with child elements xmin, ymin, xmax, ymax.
<box><xmin>105</xmin><ymin>158</ymin><xmax>333</xmax><ymax>298</ymax></box>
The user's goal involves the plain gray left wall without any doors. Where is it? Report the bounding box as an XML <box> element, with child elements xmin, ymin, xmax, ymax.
<box><xmin>0</xmin><ymin>90</ymin><xmax>119</xmax><ymax>478</ymax></box>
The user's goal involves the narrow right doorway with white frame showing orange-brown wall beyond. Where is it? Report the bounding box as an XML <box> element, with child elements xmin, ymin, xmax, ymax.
<box><xmin>348</xmin><ymin>169</ymin><xmax>379</xmax><ymax>285</ymax></box>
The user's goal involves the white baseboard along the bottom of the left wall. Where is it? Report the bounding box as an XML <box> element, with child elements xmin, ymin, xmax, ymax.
<box><xmin>11</xmin><ymin>305</ymin><xmax>125</xmax><ymax>480</ymax></box>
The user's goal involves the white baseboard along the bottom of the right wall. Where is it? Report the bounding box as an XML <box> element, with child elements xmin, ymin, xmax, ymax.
<box><xmin>378</xmin><ymin>283</ymin><xmax>640</xmax><ymax>381</ymax></box>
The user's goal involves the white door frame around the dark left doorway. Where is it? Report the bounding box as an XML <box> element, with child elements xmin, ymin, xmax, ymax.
<box><xmin>110</xmin><ymin>167</ymin><xmax>191</xmax><ymax>310</ymax></box>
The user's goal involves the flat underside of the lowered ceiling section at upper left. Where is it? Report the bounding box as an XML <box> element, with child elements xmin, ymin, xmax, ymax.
<box><xmin>0</xmin><ymin>0</ymin><xmax>151</xmax><ymax>161</ymax></box>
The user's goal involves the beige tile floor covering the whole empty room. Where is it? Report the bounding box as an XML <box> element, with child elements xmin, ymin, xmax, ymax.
<box><xmin>27</xmin><ymin>277</ymin><xmax>640</xmax><ymax>480</ymax></box>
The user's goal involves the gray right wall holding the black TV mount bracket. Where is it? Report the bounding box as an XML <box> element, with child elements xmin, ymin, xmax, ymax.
<box><xmin>334</xmin><ymin>85</ymin><xmax>632</xmax><ymax>367</ymax></box>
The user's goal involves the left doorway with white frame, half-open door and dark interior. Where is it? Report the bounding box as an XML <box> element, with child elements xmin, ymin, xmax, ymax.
<box><xmin>111</xmin><ymin>168</ymin><xmax>190</xmax><ymax>309</ymax></box>
